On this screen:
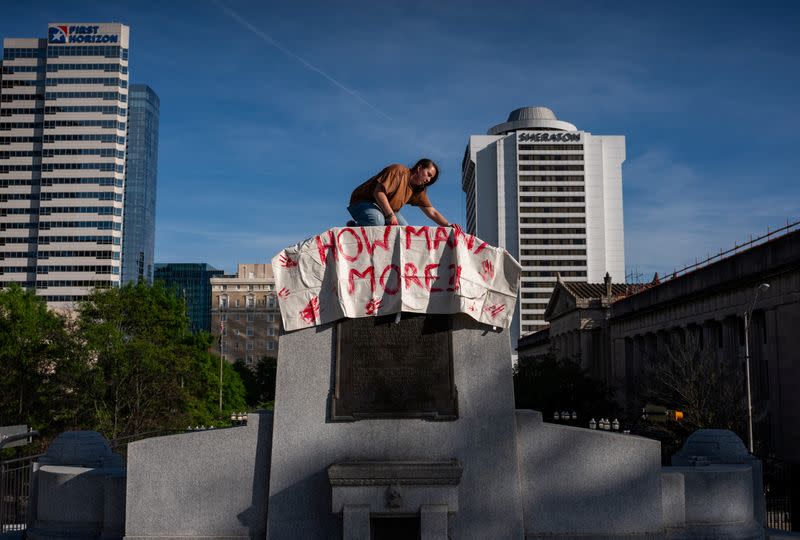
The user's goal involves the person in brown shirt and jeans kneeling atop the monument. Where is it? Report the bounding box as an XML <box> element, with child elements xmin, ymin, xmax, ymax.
<box><xmin>347</xmin><ymin>158</ymin><xmax>453</xmax><ymax>227</ymax></box>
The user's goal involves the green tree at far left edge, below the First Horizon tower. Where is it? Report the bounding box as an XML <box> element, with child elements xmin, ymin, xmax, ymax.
<box><xmin>0</xmin><ymin>284</ymin><xmax>92</xmax><ymax>437</ymax></box>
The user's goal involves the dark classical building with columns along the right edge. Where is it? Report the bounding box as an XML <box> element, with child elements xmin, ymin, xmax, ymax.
<box><xmin>518</xmin><ymin>230</ymin><xmax>800</xmax><ymax>464</ymax></box>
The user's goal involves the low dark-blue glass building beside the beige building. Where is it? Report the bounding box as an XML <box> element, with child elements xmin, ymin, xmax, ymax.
<box><xmin>154</xmin><ymin>263</ymin><xmax>225</xmax><ymax>332</ymax></box>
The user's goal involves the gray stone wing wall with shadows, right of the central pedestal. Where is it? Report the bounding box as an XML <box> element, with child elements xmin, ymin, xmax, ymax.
<box><xmin>516</xmin><ymin>410</ymin><xmax>663</xmax><ymax>538</ymax></box>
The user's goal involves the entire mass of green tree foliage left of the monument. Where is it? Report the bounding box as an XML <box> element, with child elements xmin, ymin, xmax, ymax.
<box><xmin>0</xmin><ymin>284</ymin><xmax>247</xmax><ymax>448</ymax></box>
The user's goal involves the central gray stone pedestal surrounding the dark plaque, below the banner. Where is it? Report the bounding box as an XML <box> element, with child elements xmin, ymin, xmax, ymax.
<box><xmin>268</xmin><ymin>316</ymin><xmax>524</xmax><ymax>540</ymax></box>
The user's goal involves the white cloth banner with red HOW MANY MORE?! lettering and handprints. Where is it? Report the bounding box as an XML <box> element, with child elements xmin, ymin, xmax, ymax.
<box><xmin>272</xmin><ymin>226</ymin><xmax>520</xmax><ymax>330</ymax></box>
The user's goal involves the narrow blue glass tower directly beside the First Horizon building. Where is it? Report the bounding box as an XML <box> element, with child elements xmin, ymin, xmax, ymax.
<box><xmin>122</xmin><ymin>84</ymin><xmax>159</xmax><ymax>284</ymax></box>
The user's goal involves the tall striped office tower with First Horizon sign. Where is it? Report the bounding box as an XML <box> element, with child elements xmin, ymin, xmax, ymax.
<box><xmin>0</xmin><ymin>23</ymin><xmax>129</xmax><ymax>308</ymax></box>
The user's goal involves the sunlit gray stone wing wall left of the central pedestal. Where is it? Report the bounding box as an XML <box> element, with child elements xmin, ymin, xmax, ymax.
<box><xmin>125</xmin><ymin>411</ymin><xmax>272</xmax><ymax>538</ymax></box>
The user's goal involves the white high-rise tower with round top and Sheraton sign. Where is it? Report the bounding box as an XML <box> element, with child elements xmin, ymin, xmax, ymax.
<box><xmin>462</xmin><ymin>107</ymin><xmax>625</xmax><ymax>343</ymax></box>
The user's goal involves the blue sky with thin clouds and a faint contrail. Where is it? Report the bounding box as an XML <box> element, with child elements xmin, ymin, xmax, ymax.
<box><xmin>0</xmin><ymin>0</ymin><xmax>800</xmax><ymax>278</ymax></box>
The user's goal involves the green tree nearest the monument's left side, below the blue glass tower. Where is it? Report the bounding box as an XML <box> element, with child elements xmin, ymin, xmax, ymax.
<box><xmin>78</xmin><ymin>283</ymin><xmax>244</xmax><ymax>438</ymax></box>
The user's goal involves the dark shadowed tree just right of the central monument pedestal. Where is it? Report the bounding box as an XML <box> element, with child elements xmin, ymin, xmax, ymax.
<box><xmin>514</xmin><ymin>354</ymin><xmax>620</xmax><ymax>425</ymax></box>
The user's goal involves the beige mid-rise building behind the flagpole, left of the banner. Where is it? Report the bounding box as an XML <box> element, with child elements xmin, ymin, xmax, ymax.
<box><xmin>211</xmin><ymin>264</ymin><xmax>281</xmax><ymax>367</ymax></box>
